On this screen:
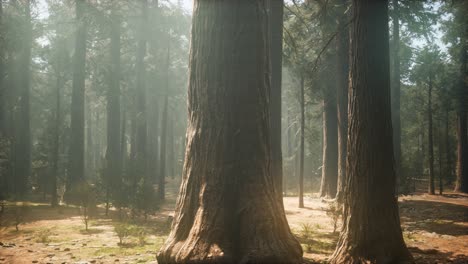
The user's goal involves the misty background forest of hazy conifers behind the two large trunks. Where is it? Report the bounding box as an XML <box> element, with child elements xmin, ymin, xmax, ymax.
<box><xmin>0</xmin><ymin>0</ymin><xmax>468</xmax><ymax>263</ymax></box>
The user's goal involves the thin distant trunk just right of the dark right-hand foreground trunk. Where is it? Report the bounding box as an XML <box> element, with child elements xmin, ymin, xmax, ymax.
<box><xmin>391</xmin><ymin>0</ymin><xmax>407</xmax><ymax>193</ymax></box>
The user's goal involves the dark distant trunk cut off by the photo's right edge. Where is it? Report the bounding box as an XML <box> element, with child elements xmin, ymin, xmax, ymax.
<box><xmin>455</xmin><ymin>11</ymin><xmax>468</xmax><ymax>193</ymax></box>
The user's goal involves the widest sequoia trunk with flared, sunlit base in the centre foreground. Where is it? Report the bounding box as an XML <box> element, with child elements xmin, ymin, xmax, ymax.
<box><xmin>157</xmin><ymin>0</ymin><xmax>302</xmax><ymax>264</ymax></box>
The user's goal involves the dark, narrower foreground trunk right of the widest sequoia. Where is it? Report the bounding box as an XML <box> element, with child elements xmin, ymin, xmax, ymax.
<box><xmin>331</xmin><ymin>0</ymin><xmax>412</xmax><ymax>264</ymax></box>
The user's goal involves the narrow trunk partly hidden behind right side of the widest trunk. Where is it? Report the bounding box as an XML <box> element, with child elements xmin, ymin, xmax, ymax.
<box><xmin>269</xmin><ymin>0</ymin><xmax>283</xmax><ymax>202</ymax></box>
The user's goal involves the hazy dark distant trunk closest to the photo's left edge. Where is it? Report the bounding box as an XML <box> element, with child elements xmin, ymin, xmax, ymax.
<box><xmin>14</xmin><ymin>0</ymin><xmax>33</xmax><ymax>198</ymax></box>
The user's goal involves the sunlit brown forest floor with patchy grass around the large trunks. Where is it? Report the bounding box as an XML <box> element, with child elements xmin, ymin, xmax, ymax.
<box><xmin>0</xmin><ymin>187</ymin><xmax>468</xmax><ymax>264</ymax></box>
